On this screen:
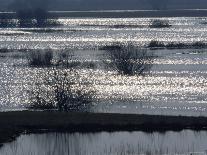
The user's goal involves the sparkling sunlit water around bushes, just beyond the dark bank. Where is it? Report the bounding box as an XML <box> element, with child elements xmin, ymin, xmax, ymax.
<box><xmin>0</xmin><ymin>49</ymin><xmax>207</xmax><ymax>115</ymax></box>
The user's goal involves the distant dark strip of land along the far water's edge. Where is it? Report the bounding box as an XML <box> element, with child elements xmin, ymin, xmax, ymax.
<box><xmin>0</xmin><ymin>9</ymin><xmax>207</xmax><ymax>18</ymax></box>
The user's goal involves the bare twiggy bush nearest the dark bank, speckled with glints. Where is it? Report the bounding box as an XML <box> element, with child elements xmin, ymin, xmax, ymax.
<box><xmin>28</xmin><ymin>69</ymin><xmax>95</xmax><ymax>111</ymax></box>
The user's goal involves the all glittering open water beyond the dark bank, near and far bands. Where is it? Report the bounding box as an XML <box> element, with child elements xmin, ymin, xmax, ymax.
<box><xmin>0</xmin><ymin>18</ymin><xmax>207</xmax><ymax>115</ymax></box>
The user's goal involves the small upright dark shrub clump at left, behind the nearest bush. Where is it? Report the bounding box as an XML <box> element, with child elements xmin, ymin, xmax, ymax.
<box><xmin>27</xmin><ymin>50</ymin><xmax>53</xmax><ymax>67</ymax></box>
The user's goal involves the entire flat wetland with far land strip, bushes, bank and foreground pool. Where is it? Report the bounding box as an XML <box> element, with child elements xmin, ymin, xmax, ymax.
<box><xmin>0</xmin><ymin>10</ymin><xmax>207</xmax><ymax>155</ymax></box>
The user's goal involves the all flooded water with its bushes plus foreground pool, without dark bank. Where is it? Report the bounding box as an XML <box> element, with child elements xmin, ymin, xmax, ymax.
<box><xmin>0</xmin><ymin>11</ymin><xmax>207</xmax><ymax>155</ymax></box>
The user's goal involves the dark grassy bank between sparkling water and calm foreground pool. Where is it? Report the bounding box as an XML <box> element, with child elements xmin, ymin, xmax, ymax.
<box><xmin>0</xmin><ymin>111</ymin><xmax>207</xmax><ymax>147</ymax></box>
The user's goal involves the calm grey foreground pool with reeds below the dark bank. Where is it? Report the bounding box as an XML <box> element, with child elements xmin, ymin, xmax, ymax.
<box><xmin>0</xmin><ymin>130</ymin><xmax>207</xmax><ymax>155</ymax></box>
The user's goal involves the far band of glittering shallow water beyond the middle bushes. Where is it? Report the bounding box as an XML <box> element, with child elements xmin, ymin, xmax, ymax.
<box><xmin>0</xmin><ymin>17</ymin><xmax>207</xmax><ymax>49</ymax></box>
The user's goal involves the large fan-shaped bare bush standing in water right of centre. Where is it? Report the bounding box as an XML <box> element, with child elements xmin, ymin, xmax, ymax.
<box><xmin>103</xmin><ymin>43</ymin><xmax>154</xmax><ymax>76</ymax></box>
